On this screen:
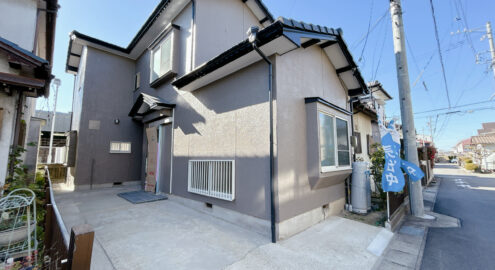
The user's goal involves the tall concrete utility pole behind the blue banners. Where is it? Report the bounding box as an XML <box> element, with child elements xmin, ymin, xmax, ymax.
<box><xmin>390</xmin><ymin>0</ymin><xmax>425</xmax><ymax>218</ymax></box>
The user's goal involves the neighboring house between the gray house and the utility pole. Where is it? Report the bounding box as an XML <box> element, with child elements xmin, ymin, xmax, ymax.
<box><xmin>353</xmin><ymin>81</ymin><xmax>392</xmax><ymax>162</ymax></box>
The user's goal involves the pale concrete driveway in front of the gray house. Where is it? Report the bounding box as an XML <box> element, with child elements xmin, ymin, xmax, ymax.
<box><xmin>55</xmin><ymin>187</ymin><xmax>391</xmax><ymax>270</ymax></box>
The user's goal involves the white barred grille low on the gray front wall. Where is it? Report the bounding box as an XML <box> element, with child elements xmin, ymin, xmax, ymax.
<box><xmin>187</xmin><ymin>160</ymin><xmax>235</xmax><ymax>201</ymax></box>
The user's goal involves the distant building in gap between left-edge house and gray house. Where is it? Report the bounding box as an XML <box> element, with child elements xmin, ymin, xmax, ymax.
<box><xmin>36</xmin><ymin>110</ymin><xmax>72</xmax><ymax>164</ymax></box>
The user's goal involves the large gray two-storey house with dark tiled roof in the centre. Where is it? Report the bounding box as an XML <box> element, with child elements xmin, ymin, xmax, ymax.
<box><xmin>66</xmin><ymin>0</ymin><xmax>368</xmax><ymax>239</ymax></box>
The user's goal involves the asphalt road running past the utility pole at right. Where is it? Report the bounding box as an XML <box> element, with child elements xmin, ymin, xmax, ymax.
<box><xmin>421</xmin><ymin>164</ymin><xmax>495</xmax><ymax>270</ymax></box>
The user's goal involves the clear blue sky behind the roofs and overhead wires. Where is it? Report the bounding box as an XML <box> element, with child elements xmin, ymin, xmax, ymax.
<box><xmin>38</xmin><ymin>0</ymin><xmax>495</xmax><ymax>150</ymax></box>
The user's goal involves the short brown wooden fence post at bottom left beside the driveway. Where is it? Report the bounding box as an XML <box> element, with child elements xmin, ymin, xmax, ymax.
<box><xmin>68</xmin><ymin>224</ymin><xmax>95</xmax><ymax>270</ymax></box>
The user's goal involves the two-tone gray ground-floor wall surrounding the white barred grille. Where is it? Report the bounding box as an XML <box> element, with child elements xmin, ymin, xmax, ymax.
<box><xmin>134</xmin><ymin>39</ymin><xmax>270</xmax><ymax>219</ymax></box>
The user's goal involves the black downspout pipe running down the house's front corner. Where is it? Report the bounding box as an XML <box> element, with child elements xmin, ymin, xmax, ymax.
<box><xmin>247</xmin><ymin>26</ymin><xmax>277</xmax><ymax>243</ymax></box>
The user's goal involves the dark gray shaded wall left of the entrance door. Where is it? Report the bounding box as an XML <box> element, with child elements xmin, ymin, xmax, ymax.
<box><xmin>74</xmin><ymin>48</ymin><xmax>142</xmax><ymax>186</ymax></box>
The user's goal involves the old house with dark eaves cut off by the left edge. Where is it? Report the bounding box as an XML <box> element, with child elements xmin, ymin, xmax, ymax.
<box><xmin>0</xmin><ymin>0</ymin><xmax>58</xmax><ymax>186</ymax></box>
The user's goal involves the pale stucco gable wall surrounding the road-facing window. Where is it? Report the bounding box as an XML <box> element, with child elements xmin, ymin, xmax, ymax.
<box><xmin>276</xmin><ymin>46</ymin><xmax>351</xmax><ymax>221</ymax></box>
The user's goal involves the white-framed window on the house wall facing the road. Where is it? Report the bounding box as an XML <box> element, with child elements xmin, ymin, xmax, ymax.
<box><xmin>317</xmin><ymin>110</ymin><xmax>352</xmax><ymax>173</ymax></box>
